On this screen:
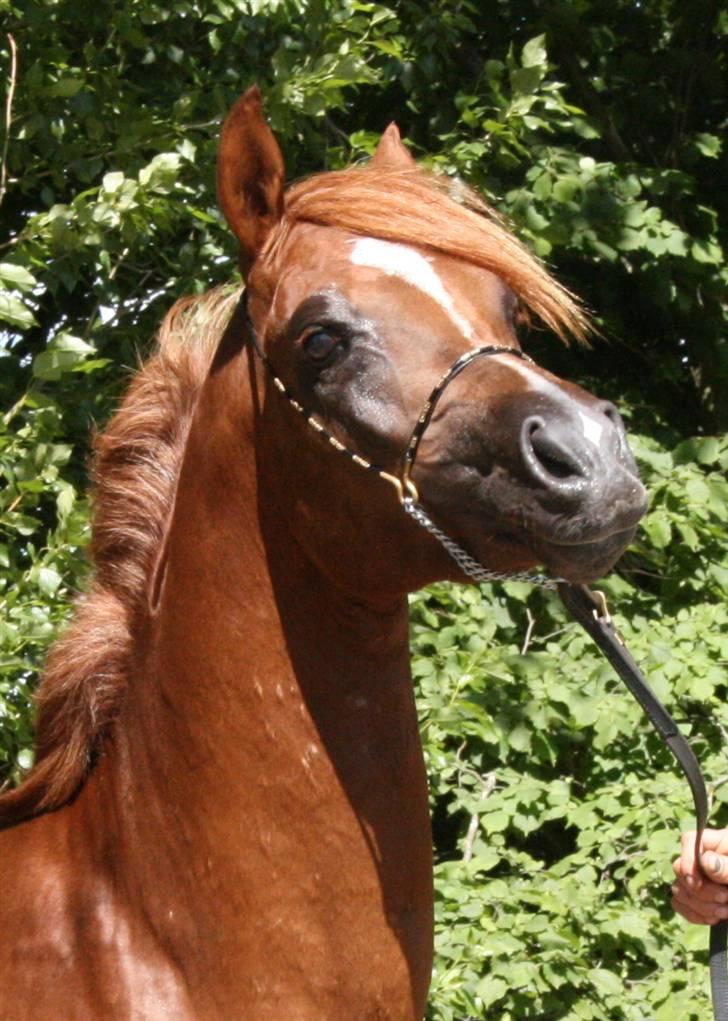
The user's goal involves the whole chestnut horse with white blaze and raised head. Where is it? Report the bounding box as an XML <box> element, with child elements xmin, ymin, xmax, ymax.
<box><xmin>0</xmin><ymin>89</ymin><xmax>644</xmax><ymax>1021</ymax></box>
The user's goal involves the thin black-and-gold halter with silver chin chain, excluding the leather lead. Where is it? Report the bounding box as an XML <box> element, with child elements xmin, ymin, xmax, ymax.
<box><xmin>241</xmin><ymin>292</ymin><xmax>562</xmax><ymax>588</ymax></box>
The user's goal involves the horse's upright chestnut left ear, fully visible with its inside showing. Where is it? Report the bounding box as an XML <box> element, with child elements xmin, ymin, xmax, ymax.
<box><xmin>217</xmin><ymin>85</ymin><xmax>286</xmax><ymax>273</ymax></box>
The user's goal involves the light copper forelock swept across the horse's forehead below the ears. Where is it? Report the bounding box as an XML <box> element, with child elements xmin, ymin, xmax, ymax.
<box><xmin>262</xmin><ymin>164</ymin><xmax>589</xmax><ymax>341</ymax></box>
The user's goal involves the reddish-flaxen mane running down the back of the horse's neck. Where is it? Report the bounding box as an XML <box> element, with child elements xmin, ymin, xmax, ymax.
<box><xmin>0</xmin><ymin>288</ymin><xmax>241</xmax><ymax>826</ymax></box>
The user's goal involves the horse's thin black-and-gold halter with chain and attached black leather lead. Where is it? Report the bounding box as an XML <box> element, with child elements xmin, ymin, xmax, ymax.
<box><xmin>240</xmin><ymin>292</ymin><xmax>728</xmax><ymax>1021</ymax></box>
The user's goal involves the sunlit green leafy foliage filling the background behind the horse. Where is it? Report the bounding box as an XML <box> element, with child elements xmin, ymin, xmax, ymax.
<box><xmin>0</xmin><ymin>0</ymin><xmax>728</xmax><ymax>1021</ymax></box>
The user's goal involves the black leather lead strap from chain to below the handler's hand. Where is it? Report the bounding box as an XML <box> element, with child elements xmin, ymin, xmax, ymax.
<box><xmin>556</xmin><ymin>582</ymin><xmax>728</xmax><ymax>1021</ymax></box>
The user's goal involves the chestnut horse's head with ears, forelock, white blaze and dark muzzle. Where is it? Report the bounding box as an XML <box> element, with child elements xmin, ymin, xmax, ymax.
<box><xmin>219</xmin><ymin>89</ymin><xmax>645</xmax><ymax>588</ymax></box>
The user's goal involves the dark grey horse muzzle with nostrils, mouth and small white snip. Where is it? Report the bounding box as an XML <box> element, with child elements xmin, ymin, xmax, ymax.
<box><xmin>416</xmin><ymin>388</ymin><xmax>646</xmax><ymax>582</ymax></box>
